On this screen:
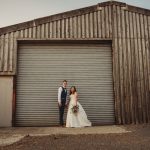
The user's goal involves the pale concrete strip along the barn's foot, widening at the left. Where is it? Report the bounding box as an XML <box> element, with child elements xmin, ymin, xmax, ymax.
<box><xmin>0</xmin><ymin>125</ymin><xmax>131</xmax><ymax>146</ymax></box>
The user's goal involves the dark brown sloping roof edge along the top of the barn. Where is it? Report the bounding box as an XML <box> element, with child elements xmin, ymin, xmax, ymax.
<box><xmin>0</xmin><ymin>1</ymin><xmax>150</xmax><ymax>35</ymax></box>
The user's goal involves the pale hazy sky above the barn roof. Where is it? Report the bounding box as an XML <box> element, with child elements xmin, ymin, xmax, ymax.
<box><xmin>0</xmin><ymin>0</ymin><xmax>150</xmax><ymax>28</ymax></box>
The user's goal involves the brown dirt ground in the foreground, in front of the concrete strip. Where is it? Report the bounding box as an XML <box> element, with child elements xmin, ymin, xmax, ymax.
<box><xmin>0</xmin><ymin>125</ymin><xmax>150</xmax><ymax>150</ymax></box>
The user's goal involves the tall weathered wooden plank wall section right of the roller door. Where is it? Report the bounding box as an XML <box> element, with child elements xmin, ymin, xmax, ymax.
<box><xmin>113</xmin><ymin>6</ymin><xmax>150</xmax><ymax>124</ymax></box>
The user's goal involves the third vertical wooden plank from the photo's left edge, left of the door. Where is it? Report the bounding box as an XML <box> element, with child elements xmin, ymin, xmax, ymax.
<box><xmin>8</xmin><ymin>32</ymin><xmax>14</xmax><ymax>72</ymax></box>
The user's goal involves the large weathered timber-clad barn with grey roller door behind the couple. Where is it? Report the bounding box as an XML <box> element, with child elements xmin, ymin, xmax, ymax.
<box><xmin>0</xmin><ymin>1</ymin><xmax>150</xmax><ymax>127</ymax></box>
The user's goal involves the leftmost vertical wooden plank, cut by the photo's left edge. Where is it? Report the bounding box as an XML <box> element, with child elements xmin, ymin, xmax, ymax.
<box><xmin>0</xmin><ymin>35</ymin><xmax>4</xmax><ymax>71</ymax></box>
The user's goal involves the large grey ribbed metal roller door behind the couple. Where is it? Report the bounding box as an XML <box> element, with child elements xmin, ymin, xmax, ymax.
<box><xmin>16</xmin><ymin>44</ymin><xmax>114</xmax><ymax>126</ymax></box>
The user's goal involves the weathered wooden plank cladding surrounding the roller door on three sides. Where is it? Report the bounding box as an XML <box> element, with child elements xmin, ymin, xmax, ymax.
<box><xmin>0</xmin><ymin>3</ymin><xmax>150</xmax><ymax>124</ymax></box>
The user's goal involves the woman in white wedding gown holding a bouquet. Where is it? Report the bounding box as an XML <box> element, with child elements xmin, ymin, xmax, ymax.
<box><xmin>66</xmin><ymin>86</ymin><xmax>91</xmax><ymax>127</ymax></box>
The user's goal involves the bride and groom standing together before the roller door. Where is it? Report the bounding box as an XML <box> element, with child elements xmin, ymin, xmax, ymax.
<box><xmin>58</xmin><ymin>80</ymin><xmax>91</xmax><ymax>127</ymax></box>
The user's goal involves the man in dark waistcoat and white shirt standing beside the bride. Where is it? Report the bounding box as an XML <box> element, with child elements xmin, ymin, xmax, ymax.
<box><xmin>58</xmin><ymin>80</ymin><xmax>67</xmax><ymax>126</ymax></box>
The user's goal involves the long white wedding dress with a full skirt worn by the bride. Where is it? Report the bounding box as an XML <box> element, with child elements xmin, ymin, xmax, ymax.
<box><xmin>66</xmin><ymin>94</ymin><xmax>91</xmax><ymax>127</ymax></box>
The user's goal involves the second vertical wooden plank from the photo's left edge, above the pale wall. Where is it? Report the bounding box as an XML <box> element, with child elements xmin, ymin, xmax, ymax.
<box><xmin>4</xmin><ymin>33</ymin><xmax>9</xmax><ymax>71</ymax></box>
